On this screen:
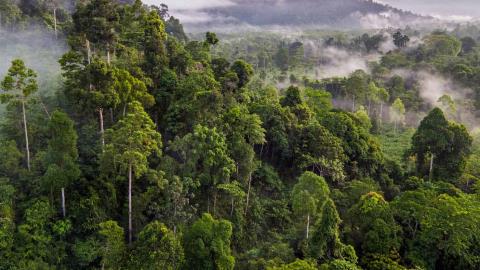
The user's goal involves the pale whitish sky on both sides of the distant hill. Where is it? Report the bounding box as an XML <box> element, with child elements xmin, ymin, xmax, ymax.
<box><xmin>144</xmin><ymin>0</ymin><xmax>480</xmax><ymax>20</ymax></box>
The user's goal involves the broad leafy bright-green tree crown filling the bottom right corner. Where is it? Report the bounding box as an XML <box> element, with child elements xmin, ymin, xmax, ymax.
<box><xmin>392</xmin><ymin>187</ymin><xmax>480</xmax><ymax>269</ymax></box>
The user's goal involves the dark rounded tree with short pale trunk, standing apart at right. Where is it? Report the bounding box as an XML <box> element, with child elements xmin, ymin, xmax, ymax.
<box><xmin>411</xmin><ymin>108</ymin><xmax>472</xmax><ymax>181</ymax></box>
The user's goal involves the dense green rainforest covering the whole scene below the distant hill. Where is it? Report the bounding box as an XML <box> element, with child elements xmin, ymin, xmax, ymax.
<box><xmin>0</xmin><ymin>0</ymin><xmax>480</xmax><ymax>270</ymax></box>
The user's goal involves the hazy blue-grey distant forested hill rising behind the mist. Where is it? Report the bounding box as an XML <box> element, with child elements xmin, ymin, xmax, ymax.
<box><xmin>179</xmin><ymin>0</ymin><xmax>424</xmax><ymax>27</ymax></box>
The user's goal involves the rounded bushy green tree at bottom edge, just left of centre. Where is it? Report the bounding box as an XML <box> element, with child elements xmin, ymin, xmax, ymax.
<box><xmin>183</xmin><ymin>214</ymin><xmax>235</xmax><ymax>270</ymax></box>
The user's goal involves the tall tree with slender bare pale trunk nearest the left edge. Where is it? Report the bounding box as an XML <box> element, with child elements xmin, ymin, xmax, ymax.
<box><xmin>0</xmin><ymin>59</ymin><xmax>38</xmax><ymax>170</ymax></box>
